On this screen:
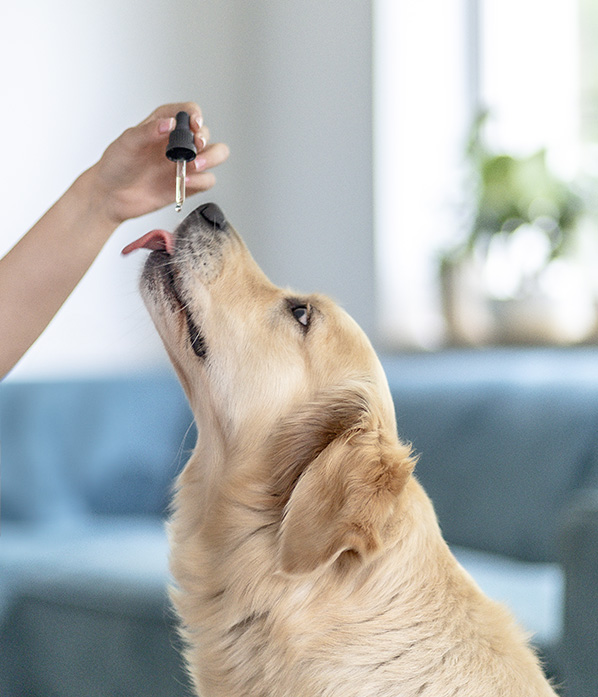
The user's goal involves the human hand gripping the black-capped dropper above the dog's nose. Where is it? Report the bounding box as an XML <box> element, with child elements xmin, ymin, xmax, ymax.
<box><xmin>82</xmin><ymin>102</ymin><xmax>229</xmax><ymax>227</ymax></box>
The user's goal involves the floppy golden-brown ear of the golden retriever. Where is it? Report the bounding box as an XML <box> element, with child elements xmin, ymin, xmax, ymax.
<box><xmin>272</xmin><ymin>390</ymin><xmax>415</xmax><ymax>575</ymax></box>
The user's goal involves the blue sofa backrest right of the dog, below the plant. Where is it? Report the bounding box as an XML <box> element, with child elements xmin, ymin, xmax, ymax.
<box><xmin>383</xmin><ymin>349</ymin><xmax>598</xmax><ymax>561</ymax></box>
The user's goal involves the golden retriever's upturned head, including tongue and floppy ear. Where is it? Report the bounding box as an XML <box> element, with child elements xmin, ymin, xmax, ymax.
<box><xmin>133</xmin><ymin>203</ymin><xmax>414</xmax><ymax>573</ymax></box>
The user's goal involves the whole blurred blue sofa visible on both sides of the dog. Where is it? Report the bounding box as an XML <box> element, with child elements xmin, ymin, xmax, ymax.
<box><xmin>0</xmin><ymin>348</ymin><xmax>598</xmax><ymax>697</ymax></box>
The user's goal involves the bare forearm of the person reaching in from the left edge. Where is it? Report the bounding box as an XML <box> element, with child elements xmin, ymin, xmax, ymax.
<box><xmin>0</xmin><ymin>170</ymin><xmax>116</xmax><ymax>378</ymax></box>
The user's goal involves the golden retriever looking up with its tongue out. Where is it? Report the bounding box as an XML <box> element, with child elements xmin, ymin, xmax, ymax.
<box><xmin>127</xmin><ymin>203</ymin><xmax>556</xmax><ymax>697</ymax></box>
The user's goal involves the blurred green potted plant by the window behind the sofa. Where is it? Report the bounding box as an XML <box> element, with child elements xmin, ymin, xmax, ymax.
<box><xmin>441</xmin><ymin>115</ymin><xmax>596</xmax><ymax>344</ymax></box>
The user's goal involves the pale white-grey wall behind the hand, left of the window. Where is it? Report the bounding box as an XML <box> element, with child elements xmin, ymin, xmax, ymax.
<box><xmin>0</xmin><ymin>0</ymin><xmax>375</xmax><ymax>379</ymax></box>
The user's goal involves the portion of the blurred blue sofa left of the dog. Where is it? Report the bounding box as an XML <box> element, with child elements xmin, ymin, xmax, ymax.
<box><xmin>0</xmin><ymin>374</ymin><xmax>195</xmax><ymax>697</ymax></box>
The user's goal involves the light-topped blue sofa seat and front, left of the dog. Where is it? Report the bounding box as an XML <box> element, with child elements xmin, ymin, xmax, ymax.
<box><xmin>0</xmin><ymin>516</ymin><xmax>188</xmax><ymax>697</ymax></box>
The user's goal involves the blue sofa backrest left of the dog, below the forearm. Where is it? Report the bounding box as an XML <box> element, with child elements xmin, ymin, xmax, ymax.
<box><xmin>0</xmin><ymin>373</ymin><xmax>195</xmax><ymax>521</ymax></box>
